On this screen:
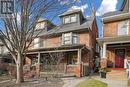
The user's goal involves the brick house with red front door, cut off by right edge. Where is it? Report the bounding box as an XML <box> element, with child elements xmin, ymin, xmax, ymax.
<box><xmin>97</xmin><ymin>0</ymin><xmax>130</xmax><ymax>68</ymax></box>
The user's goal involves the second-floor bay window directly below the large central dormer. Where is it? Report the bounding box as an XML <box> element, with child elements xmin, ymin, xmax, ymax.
<box><xmin>62</xmin><ymin>32</ymin><xmax>78</xmax><ymax>45</ymax></box>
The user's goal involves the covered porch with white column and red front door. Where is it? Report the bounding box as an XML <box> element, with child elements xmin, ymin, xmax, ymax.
<box><xmin>97</xmin><ymin>36</ymin><xmax>130</xmax><ymax>68</ymax></box>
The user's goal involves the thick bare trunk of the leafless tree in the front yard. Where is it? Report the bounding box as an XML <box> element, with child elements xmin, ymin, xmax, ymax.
<box><xmin>16</xmin><ymin>53</ymin><xmax>24</xmax><ymax>84</ymax></box>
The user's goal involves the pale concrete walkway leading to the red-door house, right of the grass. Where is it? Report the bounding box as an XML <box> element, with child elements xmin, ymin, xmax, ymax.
<box><xmin>93</xmin><ymin>76</ymin><xmax>128</xmax><ymax>87</ymax></box>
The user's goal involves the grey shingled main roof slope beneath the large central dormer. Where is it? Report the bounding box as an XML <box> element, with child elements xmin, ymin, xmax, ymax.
<box><xmin>39</xmin><ymin>17</ymin><xmax>94</xmax><ymax>36</ymax></box>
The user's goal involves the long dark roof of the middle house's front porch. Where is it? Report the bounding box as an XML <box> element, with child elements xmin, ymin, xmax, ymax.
<box><xmin>27</xmin><ymin>44</ymin><xmax>90</xmax><ymax>54</ymax></box>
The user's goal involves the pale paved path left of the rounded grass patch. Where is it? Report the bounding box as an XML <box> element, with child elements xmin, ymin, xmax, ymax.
<box><xmin>62</xmin><ymin>77</ymin><xmax>87</xmax><ymax>87</ymax></box>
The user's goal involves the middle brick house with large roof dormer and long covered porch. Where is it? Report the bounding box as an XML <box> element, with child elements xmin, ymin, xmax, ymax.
<box><xmin>25</xmin><ymin>8</ymin><xmax>98</xmax><ymax>77</ymax></box>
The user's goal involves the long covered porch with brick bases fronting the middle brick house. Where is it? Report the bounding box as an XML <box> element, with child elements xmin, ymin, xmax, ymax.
<box><xmin>26</xmin><ymin>45</ymin><xmax>90</xmax><ymax>77</ymax></box>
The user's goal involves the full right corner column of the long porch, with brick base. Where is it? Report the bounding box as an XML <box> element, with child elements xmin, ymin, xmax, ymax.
<box><xmin>75</xmin><ymin>49</ymin><xmax>81</xmax><ymax>77</ymax></box>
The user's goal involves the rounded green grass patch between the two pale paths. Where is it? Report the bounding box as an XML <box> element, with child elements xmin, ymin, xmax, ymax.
<box><xmin>76</xmin><ymin>79</ymin><xmax>107</xmax><ymax>87</ymax></box>
